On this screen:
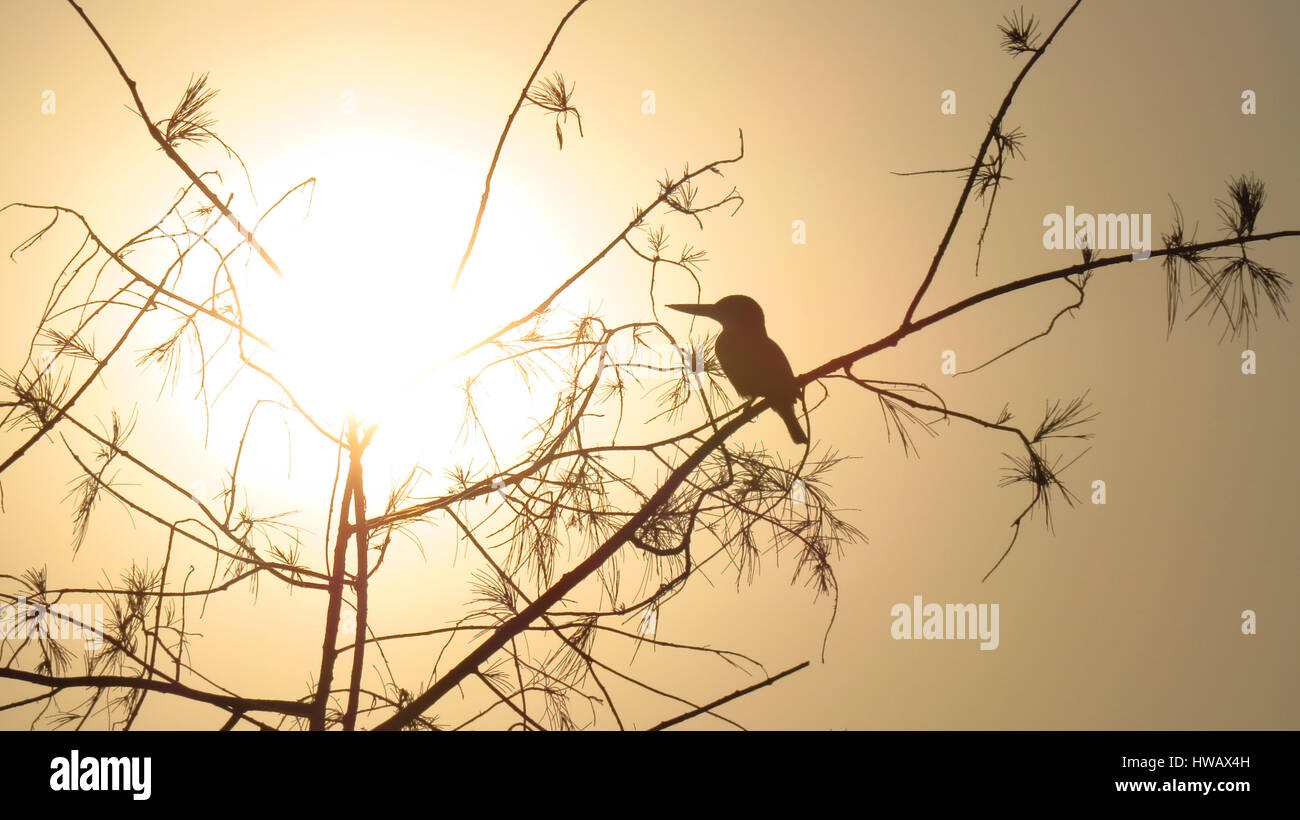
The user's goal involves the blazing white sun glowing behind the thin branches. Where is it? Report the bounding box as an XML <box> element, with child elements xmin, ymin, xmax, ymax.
<box><xmin>231</xmin><ymin>134</ymin><xmax>563</xmax><ymax>483</ymax></box>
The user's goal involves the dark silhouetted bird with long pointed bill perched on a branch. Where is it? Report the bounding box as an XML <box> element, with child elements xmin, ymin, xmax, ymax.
<box><xmin>666</xmin><ymin>295</ymin><xmax>809</xmax><ymax>444</ymax></box>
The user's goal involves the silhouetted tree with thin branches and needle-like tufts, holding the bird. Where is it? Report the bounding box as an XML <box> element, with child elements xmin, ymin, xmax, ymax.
<box><xmin>0</xmin><ymin>0</ymin><xmax>1300</xmax><ymax>729</ymax></box>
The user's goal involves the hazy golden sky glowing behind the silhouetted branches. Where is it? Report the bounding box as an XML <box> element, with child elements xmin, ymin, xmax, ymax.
<box><xmin>0</xmin><ymin>0</ymin><xmax>1300</xmax><ymax>729</ymax></box>
